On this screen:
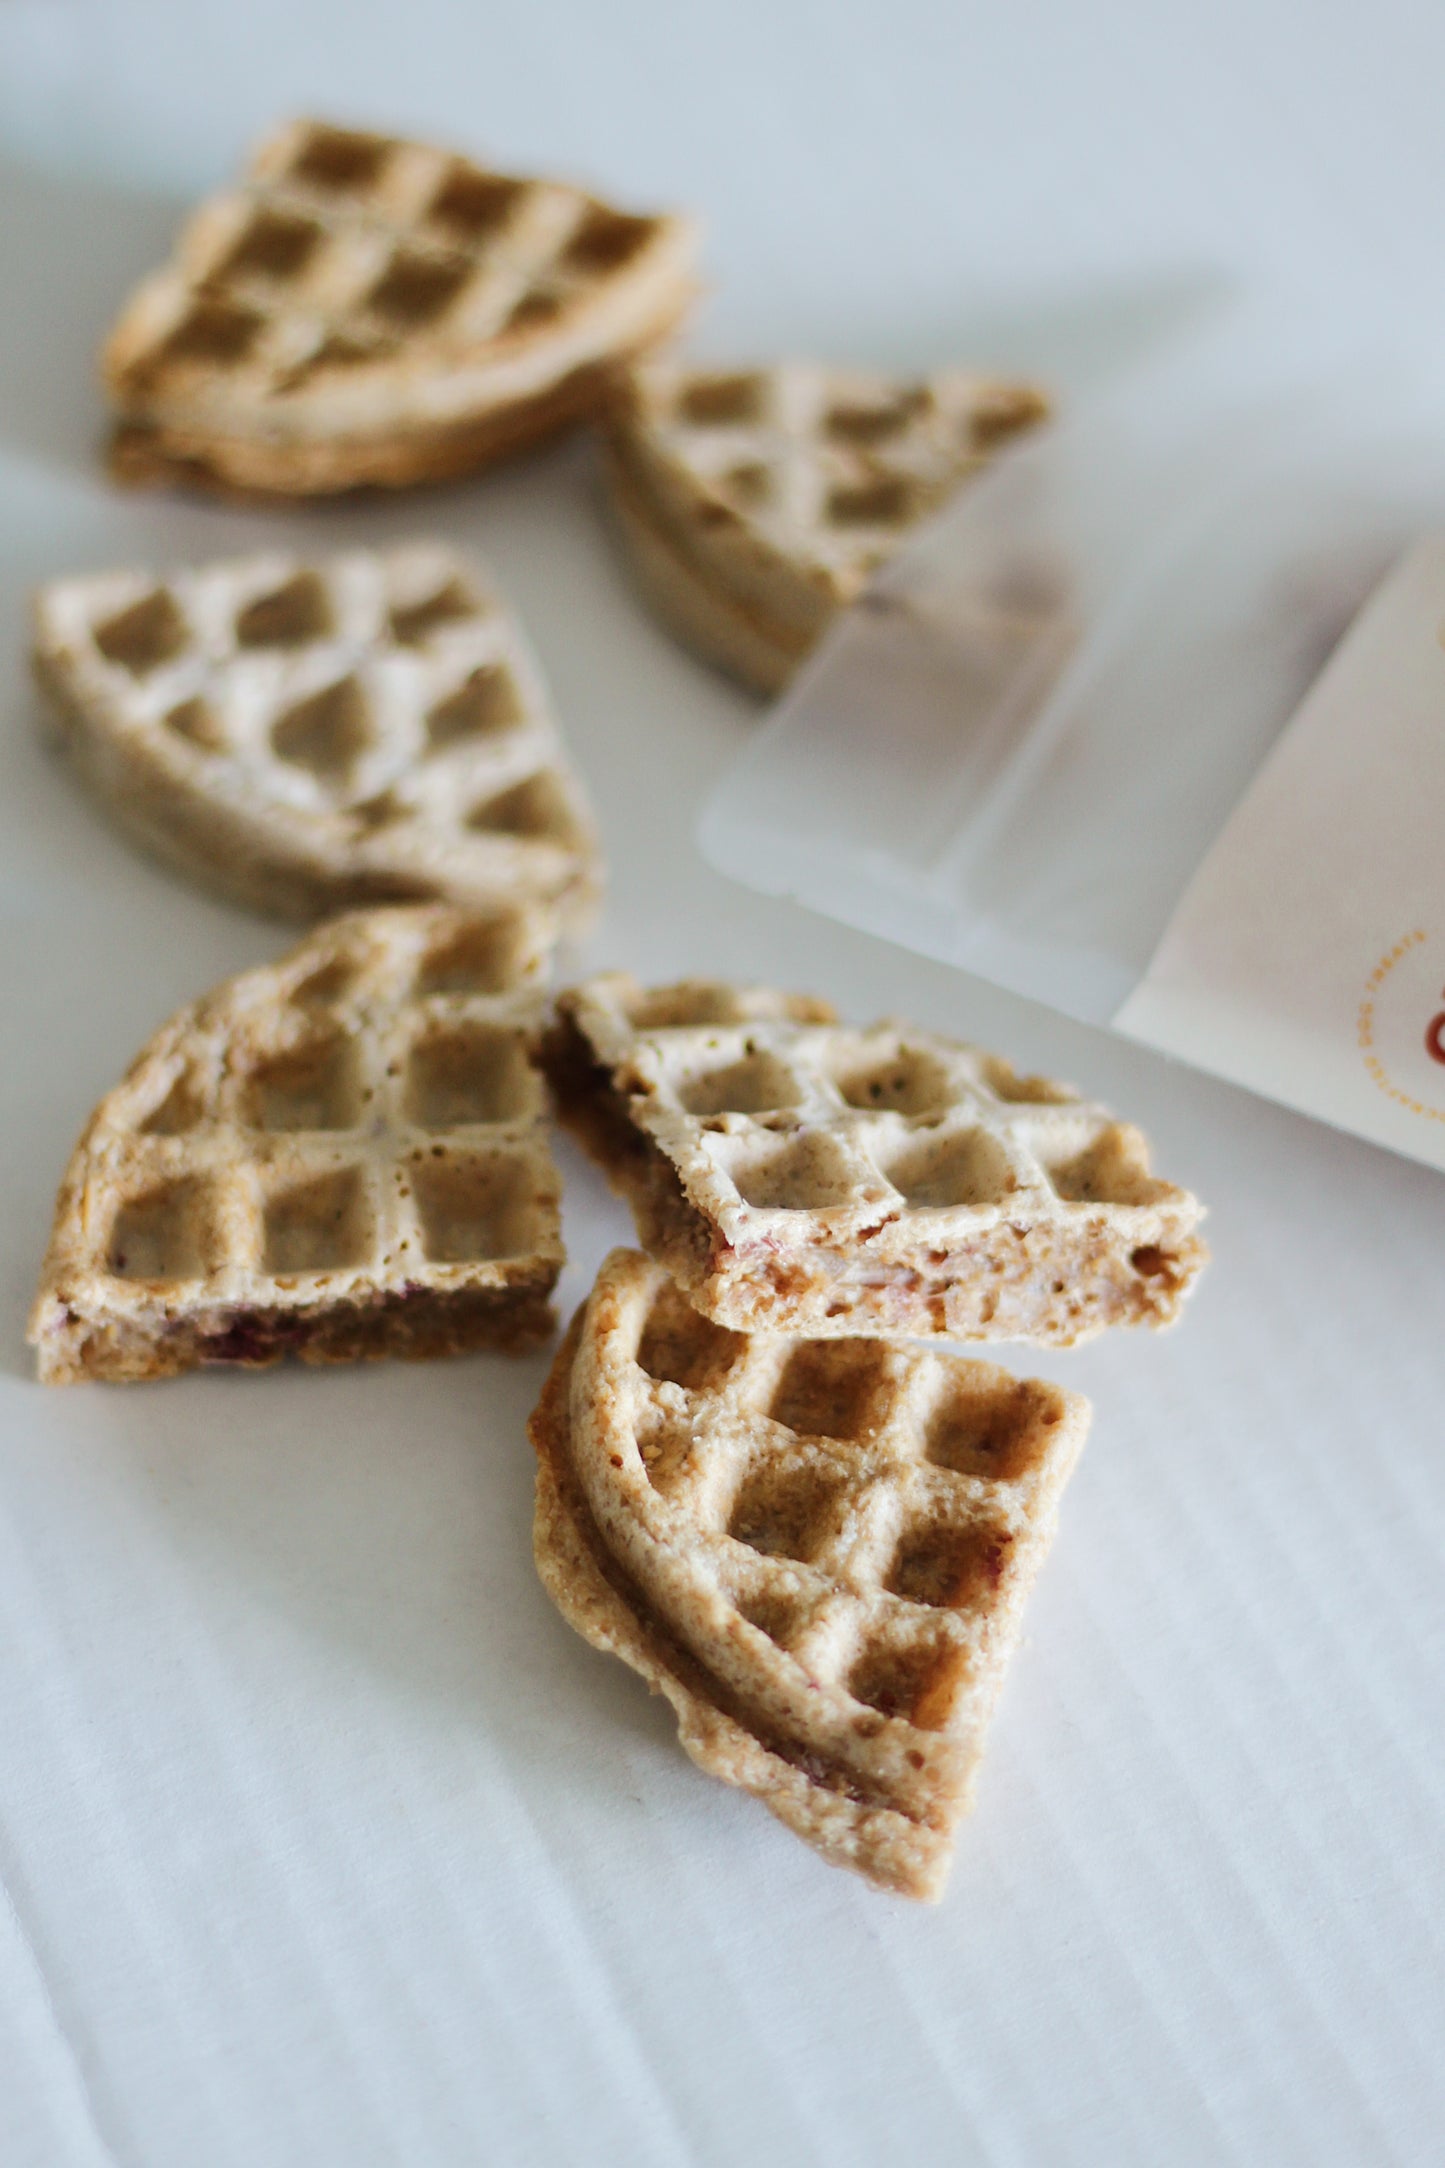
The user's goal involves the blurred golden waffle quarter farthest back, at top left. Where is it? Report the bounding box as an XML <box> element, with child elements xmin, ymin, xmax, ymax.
<box><xmin>104</xmin><ymin>121</ymin><xmax>695</xmax><ymax>494</ymax></box>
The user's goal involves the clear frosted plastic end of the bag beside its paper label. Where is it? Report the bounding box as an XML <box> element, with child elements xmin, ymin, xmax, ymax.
<box><xmin>702</xmin><ymin>307</ymin><xmax>1445</xmax><ymax>1158</ymax></box>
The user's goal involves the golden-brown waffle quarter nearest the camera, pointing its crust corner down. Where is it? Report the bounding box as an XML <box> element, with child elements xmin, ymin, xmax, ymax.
<box><xmin>531</xmin><ymin>1251</ymin><xmax>1090</xmax><ymax>1897</ymax></box>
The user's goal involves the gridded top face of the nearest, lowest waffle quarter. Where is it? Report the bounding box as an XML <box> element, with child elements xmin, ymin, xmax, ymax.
<box><xmin>635</xmin><ymin>1286</ymin><xmax>1066</xmax><ymax>1732</ymax></box>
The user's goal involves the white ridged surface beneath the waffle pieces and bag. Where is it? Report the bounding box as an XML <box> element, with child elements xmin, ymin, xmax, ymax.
<box><xmin>0</xmin><ymin>0</ymin><xmax>1445</xmax><ymax>2168</ymax></box>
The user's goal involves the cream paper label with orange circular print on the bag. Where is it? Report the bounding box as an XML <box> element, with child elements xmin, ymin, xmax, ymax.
<box><xmin>1114</xmin><ymin>538</ymin><xmax>1445</xmax><ymax>1169</ymax></box>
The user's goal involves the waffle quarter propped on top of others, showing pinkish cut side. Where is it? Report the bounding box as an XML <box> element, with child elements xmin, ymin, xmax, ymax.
<box><xmin>544</xmin><ymin>973</ymin><xmax>1207</xmax><ymax>1346</ymax></box>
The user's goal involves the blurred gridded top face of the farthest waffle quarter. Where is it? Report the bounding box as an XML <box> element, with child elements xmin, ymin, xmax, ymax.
<box><xmin>110</xmin><ymin>121</ymin><xmax>672</xmax><ymax>408</ymax></box>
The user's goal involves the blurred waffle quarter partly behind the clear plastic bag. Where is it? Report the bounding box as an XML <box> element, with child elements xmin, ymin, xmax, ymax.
<box><xmin>611</xmin><ymin>362</ymin><xmax>1046</xmax><ymax>692</ymax></box>
